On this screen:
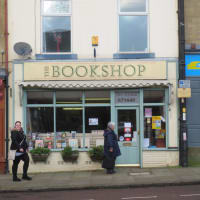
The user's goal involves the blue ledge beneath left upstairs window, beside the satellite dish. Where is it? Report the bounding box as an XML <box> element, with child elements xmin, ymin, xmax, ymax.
<box><xmin>35</xmin><ymin>54</ymin><xmax>78</xmax><ymax>60</ymax></box>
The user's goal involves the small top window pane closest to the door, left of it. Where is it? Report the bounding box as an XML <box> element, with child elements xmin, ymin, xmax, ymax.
<box><xmin>85</xmin><ymin>90</ymin><xmax>110</xmax><ymax>103</ymax></box>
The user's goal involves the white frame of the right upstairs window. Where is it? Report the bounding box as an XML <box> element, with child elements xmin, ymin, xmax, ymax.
<box><xmin>117</xmin><ymin>0</ymin><xmax>150</xmax><ymax>54</ymax></box>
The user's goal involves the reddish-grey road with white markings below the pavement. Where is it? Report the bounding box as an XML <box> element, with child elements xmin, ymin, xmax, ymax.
<box><xmin>0</xmin><ymin>185</ymin><xmax>200</xmax><ymax>200</ymax></box>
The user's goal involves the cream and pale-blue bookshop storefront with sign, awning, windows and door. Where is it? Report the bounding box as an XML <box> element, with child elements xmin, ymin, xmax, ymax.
<box><xmin>12</xmin><ymin>61</ymin><xmax>178</xmax><ymax>171</ymax></box>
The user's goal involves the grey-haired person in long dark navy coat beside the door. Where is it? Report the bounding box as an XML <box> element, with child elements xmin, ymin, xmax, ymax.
<box><xmin>102</xmin><ymin>122</ymin><xmax>121</xmax><ymax>174</ymax></box>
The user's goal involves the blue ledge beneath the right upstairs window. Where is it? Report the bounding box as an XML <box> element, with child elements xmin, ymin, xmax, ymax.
<box><xmin>113</xmin><ymin>53</ymin><xmax>155</xmax><ymax>59</ymax></box>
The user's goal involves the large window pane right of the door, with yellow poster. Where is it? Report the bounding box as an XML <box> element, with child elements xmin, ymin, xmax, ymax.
<box><xmin>143</xmin><ymin>106</ymin><xmax>166</xmax><ymax>148</ymax></box>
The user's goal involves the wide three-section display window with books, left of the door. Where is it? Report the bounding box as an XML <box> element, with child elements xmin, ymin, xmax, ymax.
<box><xmin>26</xmin><ymin>90</ymin><xmax>111</xmax><ymax>149</ymax></box>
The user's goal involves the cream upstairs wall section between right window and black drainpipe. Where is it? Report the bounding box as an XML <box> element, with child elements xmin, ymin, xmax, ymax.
<box><xmin>149</xmin><ymin>0</ymin><xmax>178</xmax><ymax>57</ymax></box>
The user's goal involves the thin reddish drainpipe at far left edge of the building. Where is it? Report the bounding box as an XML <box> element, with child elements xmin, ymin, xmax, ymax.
<box><xmin>4</xmin><ymin>0</ymin><xmax>9</xmax><ymax>173</ymax></box>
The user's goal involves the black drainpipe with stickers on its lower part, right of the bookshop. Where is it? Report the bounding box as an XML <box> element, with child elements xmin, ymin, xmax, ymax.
<box><xmin>178</xmin><ymin>0</ymin><xmax>188</xmax><ymax>167</ymax></box>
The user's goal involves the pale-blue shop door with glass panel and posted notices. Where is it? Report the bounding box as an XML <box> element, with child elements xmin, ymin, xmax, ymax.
<box><xmin>116</xmin><ymin>107</ymin><xmax>140</xmax><ymax>166</ymax></box>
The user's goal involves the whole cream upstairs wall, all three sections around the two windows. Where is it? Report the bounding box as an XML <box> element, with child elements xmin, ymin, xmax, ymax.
<box><xmin>8</xmin><ymin>0</ymin><xmax>178</xmax><ymax>60</ymax></box>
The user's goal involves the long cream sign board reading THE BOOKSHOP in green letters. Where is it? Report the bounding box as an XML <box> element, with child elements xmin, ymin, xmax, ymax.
<box><xmin>24</xmin><ymin>61</ymin><xmax>166</xmax><ymax>81</ymax></box>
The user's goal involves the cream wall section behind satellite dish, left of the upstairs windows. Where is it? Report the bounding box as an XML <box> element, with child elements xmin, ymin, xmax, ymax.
<box><xmin>8</xmin><ymin>0</ymin><xmax>36</xmax><ymax>60</ymax></box>
